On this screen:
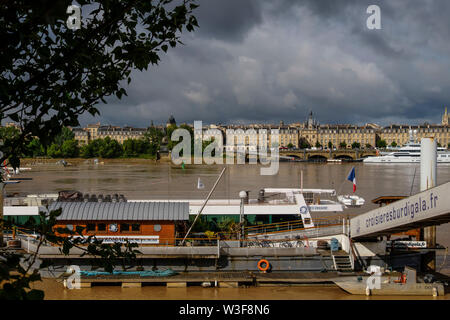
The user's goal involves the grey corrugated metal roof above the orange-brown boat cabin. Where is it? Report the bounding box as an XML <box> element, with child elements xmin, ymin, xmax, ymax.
<box><xmin>49</xmin><ymin>202</ymin><xmax>189</xmax><ymax>221</ymax></box>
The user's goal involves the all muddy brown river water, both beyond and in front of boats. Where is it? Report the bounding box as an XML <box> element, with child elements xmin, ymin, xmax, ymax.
<box><xmin>6</xmin><ymin>161</ymin><xmax>450</xmax><ymax>300</ymax></box>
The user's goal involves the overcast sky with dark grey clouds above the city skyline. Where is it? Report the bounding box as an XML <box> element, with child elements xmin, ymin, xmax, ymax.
<box><xmin>81</xmin><ymin>0</ymin><xmax>450</xmax><ymax>127</ymax></box>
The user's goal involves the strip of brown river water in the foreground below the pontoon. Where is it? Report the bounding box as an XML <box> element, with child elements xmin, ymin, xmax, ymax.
<box><xmin>32</xmin><ymin>279</ymin><xmax>450</xmax><ymax>300</ymax></box>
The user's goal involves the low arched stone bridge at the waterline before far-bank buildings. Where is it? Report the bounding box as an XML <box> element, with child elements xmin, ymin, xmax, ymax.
<box><xmin>280</xmin><ymin>149</ymin><xmax>376</xmax><ymax>161</ymax></box>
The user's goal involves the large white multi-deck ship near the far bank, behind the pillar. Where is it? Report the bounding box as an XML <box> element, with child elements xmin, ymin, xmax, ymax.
<box><xmin>363</xmin><ymin>141</ymin><xmax>450</xmax><ymax>163</ymax></box>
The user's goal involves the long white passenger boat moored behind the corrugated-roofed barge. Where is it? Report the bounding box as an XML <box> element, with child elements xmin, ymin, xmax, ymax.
<box><xmin>4</xmin><ymin>188</ymin><xmax>346</xmax><ymax>228</ymax></box>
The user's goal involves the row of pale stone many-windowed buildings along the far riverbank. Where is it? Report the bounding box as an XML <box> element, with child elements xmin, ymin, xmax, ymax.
<box><xmin>67</xmin><ymin>108</ymin><xmax>450</xmax><ymax>149</ymax></box>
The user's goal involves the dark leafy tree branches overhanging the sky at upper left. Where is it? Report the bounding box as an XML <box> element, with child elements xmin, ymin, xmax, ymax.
<box><xmin>0</xmin><ymin>0</ymin><xmax>198</xmax><ymax>168</ymax></box>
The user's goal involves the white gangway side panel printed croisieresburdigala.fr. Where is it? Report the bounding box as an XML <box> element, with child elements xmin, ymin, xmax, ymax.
<box><xmin>350</xmin><ymin>182</ymin><xmax>450</xmax><ymax>240</ymax></box>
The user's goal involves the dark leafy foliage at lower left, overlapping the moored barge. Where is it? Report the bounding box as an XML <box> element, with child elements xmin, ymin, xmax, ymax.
<box><xmin>0</xmin><ymin>209</ymin><xmax>140</xmax><ymax>300</ymax></box>
